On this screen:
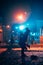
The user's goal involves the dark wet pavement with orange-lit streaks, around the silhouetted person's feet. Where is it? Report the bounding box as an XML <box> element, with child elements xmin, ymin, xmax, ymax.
<box><xmin>0</xmin><ymin>48</ymin><xmax>43</xmax><ymax>65</ymax></box>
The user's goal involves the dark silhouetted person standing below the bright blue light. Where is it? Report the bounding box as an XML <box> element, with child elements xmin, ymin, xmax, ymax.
<box><xmin>19</xmin><ymin>28</ymin><xmax>30</xmax><ymax>65</ymax></box>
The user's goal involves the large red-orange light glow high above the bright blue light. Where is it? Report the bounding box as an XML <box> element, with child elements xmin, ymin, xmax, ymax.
<box><xmin>13</xmin><ymin>11</ymin><xmax>28</xmax><ymax>23</ymax></box>
